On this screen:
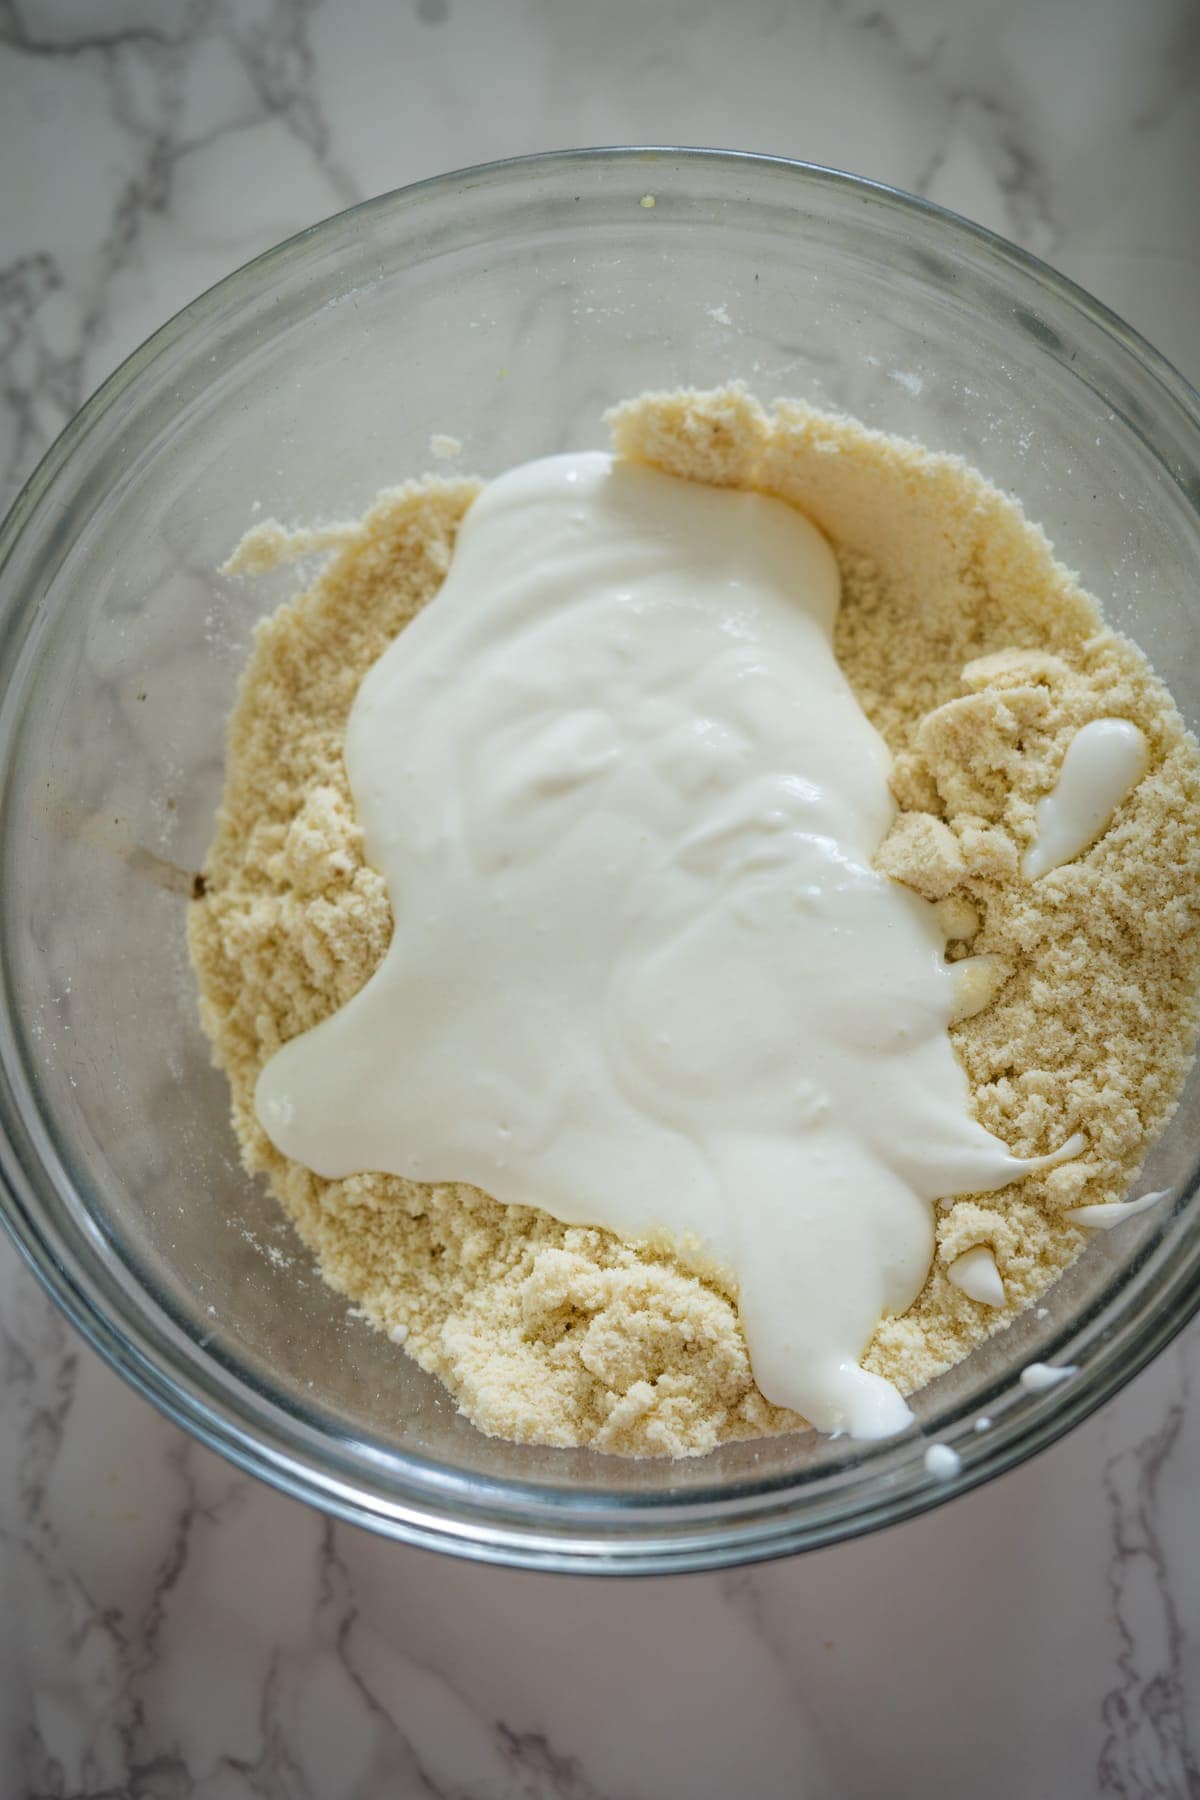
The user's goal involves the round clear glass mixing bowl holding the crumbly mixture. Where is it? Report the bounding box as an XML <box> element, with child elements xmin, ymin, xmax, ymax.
<box><xmin>0</xmin><ymin>149</ymin><xmax>1200</xmax><ymax>1573</ymax></box>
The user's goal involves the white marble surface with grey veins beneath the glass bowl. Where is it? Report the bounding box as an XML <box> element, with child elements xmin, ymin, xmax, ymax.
<box><xmin>0</xmin><ymin>0</ymin><xmax>1200</xmax><ymax>1800</ymax></box>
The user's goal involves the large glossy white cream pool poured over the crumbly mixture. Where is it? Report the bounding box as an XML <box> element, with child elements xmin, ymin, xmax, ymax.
<box><xmin>257</xmin><ymin>454</ymin><xmax>1079</xmax><ymax>1436</ymax></box>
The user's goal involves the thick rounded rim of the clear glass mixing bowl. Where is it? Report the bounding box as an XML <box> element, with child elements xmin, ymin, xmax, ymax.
<box><xmin>0</xmin><ymin>144</ymin><xmax>1200</xmax><ymax>1575</ymax></box>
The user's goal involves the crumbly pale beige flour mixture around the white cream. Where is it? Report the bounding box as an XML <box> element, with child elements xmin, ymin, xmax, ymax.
<box><xmin>189</xmin><ymin>389</ymin><xmax>1200</xmax><ymax>1454</ymax></box>
